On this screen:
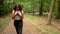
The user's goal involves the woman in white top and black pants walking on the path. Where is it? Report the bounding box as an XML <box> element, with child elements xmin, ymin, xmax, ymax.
<box><xmin>12</xmin><ymin>4</ymin><xmax>23</xmax><ymax>34</ymax></box>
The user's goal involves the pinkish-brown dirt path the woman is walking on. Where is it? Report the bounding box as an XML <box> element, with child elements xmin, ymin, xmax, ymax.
<box><xmin>3</xmin><ymin>19</ymin><xmax>40</xmax><ymax>34</ymax></box>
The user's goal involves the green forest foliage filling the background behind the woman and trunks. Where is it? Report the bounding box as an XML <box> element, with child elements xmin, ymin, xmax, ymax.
<box><xmin>0</xmin><ymin>0</ymin><xmax>59</xmax><ymax>14</ymax></box>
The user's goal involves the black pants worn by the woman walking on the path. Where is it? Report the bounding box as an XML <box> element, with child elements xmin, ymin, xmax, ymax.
<box><xmin>14</xmin><ymin>20</ymin><xmax>23</xmax><ymax>34</ymax></box>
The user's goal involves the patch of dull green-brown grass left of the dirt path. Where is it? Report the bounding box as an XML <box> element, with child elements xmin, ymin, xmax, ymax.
<box><xmin>0</xmin><ymin>15</ymin><xmax>11</xmax><ymax>32</ymax></box>
